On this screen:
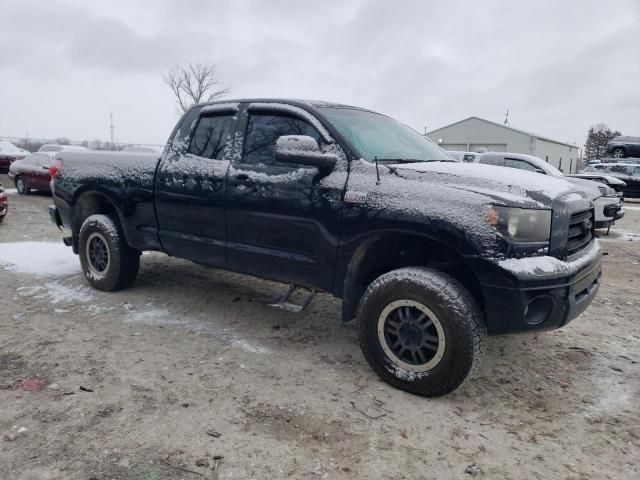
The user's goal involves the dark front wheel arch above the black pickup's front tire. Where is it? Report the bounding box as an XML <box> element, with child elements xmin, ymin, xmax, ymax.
<box><xmin>341</xmin><ymin>231</ymin><xmax>484</xmax><ymax>322</ymax></box>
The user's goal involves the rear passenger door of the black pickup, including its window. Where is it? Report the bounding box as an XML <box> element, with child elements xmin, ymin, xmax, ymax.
<box><xmin>155</xmin><ymin>106</ymin><xmax>237</xmax><ymax>267</ymax></box>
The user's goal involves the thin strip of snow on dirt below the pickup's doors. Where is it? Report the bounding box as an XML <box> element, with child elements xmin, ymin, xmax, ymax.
<box><xmin>124</xmin><ymin>304</ymin><xmax>270</xmax><ymax>353</ymax></box>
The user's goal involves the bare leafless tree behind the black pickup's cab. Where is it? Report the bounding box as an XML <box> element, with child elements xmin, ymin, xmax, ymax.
<box><xmin>162</xmin><ymin>63</ymin><xmax>231</xmax><ymax>112</ymax></box>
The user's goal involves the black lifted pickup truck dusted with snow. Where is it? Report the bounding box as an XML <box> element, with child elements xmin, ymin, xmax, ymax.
<box><xmin>50</xmin><ymin>99</ymin><xmax>601</xmax><ymax>396</ymax></box>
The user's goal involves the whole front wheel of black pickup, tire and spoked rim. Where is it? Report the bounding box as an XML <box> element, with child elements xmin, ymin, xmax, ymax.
<box><xmin>358</xmin><ymin>267</ymin><xmax>486</xmax><ymax>397</ymax></box>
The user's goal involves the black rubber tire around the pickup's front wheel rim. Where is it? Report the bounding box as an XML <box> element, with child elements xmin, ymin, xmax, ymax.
<box><xmin>357</xmin><ymin>267</ymin><xmax>486</xmax><ymax>397</ymax></box>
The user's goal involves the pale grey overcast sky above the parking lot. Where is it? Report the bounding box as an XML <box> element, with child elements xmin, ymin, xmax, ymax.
<box><xmin>0</xmin><ymin>0</ymin><xmax>640</xmax><ymax>145</ymax></box>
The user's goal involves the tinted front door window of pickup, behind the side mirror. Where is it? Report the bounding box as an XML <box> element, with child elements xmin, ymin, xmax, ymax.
<box><xmin>243</xmin><ymin>114</ymin><xmax>320</xmax><ymax>165</ymax></box>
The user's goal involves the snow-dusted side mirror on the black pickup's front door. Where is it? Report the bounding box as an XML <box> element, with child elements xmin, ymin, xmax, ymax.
<box><xmin>274</xmin><ymin>135</ymin><xmax>338</xmax><ymax>173</ymax></box>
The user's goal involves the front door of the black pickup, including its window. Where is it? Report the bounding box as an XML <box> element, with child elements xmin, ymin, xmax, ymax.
<box><xmin>226</xmin><ymin>104</ymin><xmax>346</xmax><ymax>290</ymax></box>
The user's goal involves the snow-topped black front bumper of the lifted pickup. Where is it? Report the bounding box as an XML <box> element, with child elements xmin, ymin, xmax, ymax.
<box><xmin>472</xmin><ymin>241</ymin><xmax>602</xmax><ymax>335</ymax></box>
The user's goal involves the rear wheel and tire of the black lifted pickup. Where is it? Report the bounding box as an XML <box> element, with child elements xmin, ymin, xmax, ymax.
<box><xmin>78</xmin><ymin>215</ymin><xmax>140</xmax><ymax>292</ymax></box>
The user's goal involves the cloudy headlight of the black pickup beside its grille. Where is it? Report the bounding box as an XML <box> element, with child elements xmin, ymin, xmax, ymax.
<box><xmin>485</xmin><ymin>206</ymin><xmax>551</xmax><ymax>242</ymax></box>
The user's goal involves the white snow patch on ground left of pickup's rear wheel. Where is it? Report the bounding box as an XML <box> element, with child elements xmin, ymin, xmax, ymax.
<box><xmin>0</xmin><ymin>242</ymin><xmax>81</xmax><ymax>277</ymax></box>
